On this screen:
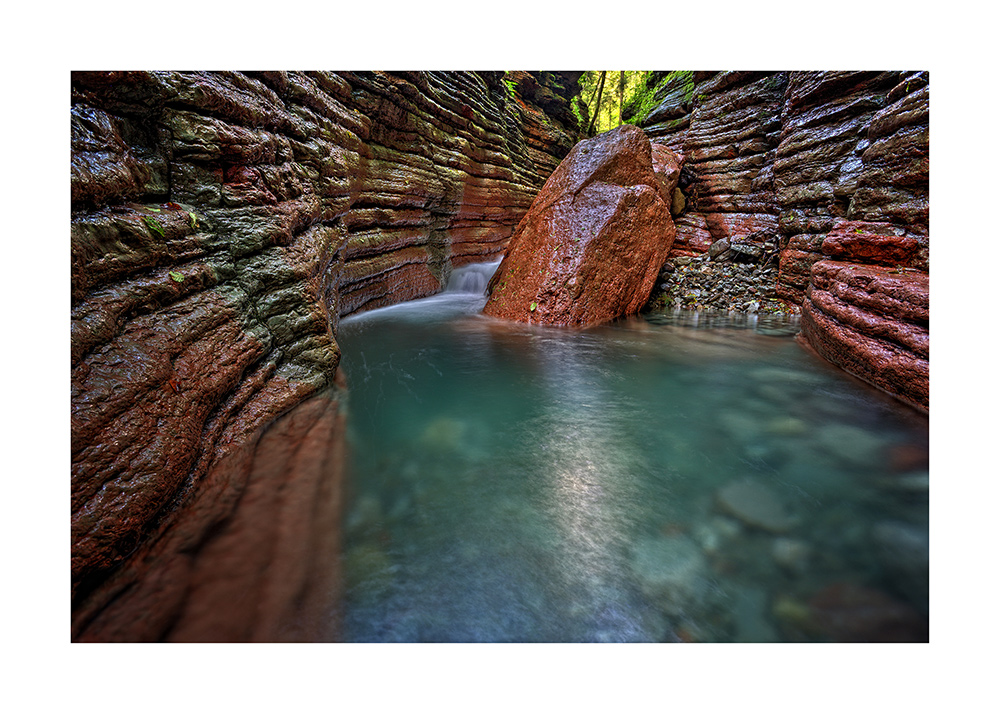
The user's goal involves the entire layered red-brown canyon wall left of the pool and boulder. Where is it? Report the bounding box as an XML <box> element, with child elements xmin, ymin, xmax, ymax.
<box><xmin>70</xmin><ymin>72</ymin><xmax>575</xmax><ymax>640</ymax></box>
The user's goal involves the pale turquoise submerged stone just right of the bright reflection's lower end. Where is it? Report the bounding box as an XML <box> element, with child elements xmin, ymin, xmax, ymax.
<box><xmin>632</xmin><ymin>536</ymin><xmax>708</xmax><ymax>615</ymax></box>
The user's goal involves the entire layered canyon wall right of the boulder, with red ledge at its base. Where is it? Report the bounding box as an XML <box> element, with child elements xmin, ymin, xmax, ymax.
<box><xmin>642</xmin><ymin>71</ymin><xmax>929</xmax><ymax>409</ymax></box>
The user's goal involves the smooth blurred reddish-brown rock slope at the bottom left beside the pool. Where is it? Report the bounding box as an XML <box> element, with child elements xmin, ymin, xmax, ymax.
<box><xmin>72</xmin><ymin>390</ymin><xmax>344</xmax><ymax>642</ymax></box>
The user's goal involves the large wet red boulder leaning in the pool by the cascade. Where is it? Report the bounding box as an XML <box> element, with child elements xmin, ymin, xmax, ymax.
<box><xmin>483</xmin><ymin>124</ymin><xmax>679</xmax><ymax>327</ymax></box>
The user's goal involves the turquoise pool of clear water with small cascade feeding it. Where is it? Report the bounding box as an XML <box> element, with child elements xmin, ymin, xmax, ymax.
<box><xmin>339</xmin><ymin>264</ymin><xmax>929</xmax><ymax>642</ymax></box>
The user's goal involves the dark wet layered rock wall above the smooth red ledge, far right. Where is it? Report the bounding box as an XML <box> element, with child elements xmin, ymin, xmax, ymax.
<box><xmin>774</xmin><ymin>72</ymin><xmax>928</xmax><ymax>302</ymax></box>
